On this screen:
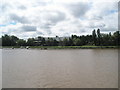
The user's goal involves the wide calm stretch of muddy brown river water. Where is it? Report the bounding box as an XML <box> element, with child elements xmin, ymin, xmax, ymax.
<box><xmin>3</xmin><ymin>49</ymin><xmax>118</xmax><ymax>88</ymax></box>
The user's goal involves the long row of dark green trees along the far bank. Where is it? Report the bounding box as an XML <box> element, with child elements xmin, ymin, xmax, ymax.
<box><xmin>0</xmin><ymin>29</ymin><xmax>120</xmax><ymax>46</ymax></box>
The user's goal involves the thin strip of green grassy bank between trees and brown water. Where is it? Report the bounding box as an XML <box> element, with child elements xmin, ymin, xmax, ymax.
<box><xmin>0</xmin><ymin>46</ymin><xmax>119</xmax><ymax>49</ymax></box>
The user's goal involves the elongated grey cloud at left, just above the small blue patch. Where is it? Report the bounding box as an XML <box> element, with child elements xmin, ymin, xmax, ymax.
<box><xmin>9</xmin><ymin>14</ymin><xmax>30</xmax><ymax>24</ymax></box>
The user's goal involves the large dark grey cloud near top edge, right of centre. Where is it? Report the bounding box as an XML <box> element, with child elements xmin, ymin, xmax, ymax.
<box><xmin>67</xmin><ymin>2</ymin><xmax>90</xmax><ymax>17</ymax></box>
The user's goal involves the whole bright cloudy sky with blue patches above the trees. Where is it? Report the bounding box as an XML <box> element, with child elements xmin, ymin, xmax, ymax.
<box><xmin>0</xmin><ymin>0</ymin><xmax>118</xmax><ymax>38</ymax></box>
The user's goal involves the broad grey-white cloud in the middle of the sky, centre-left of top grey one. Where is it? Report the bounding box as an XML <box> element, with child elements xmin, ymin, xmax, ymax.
<box><xmin>40</xmin><ymin>11</ymin><xmax>66</xmax><ymax>30</ymax></box>
